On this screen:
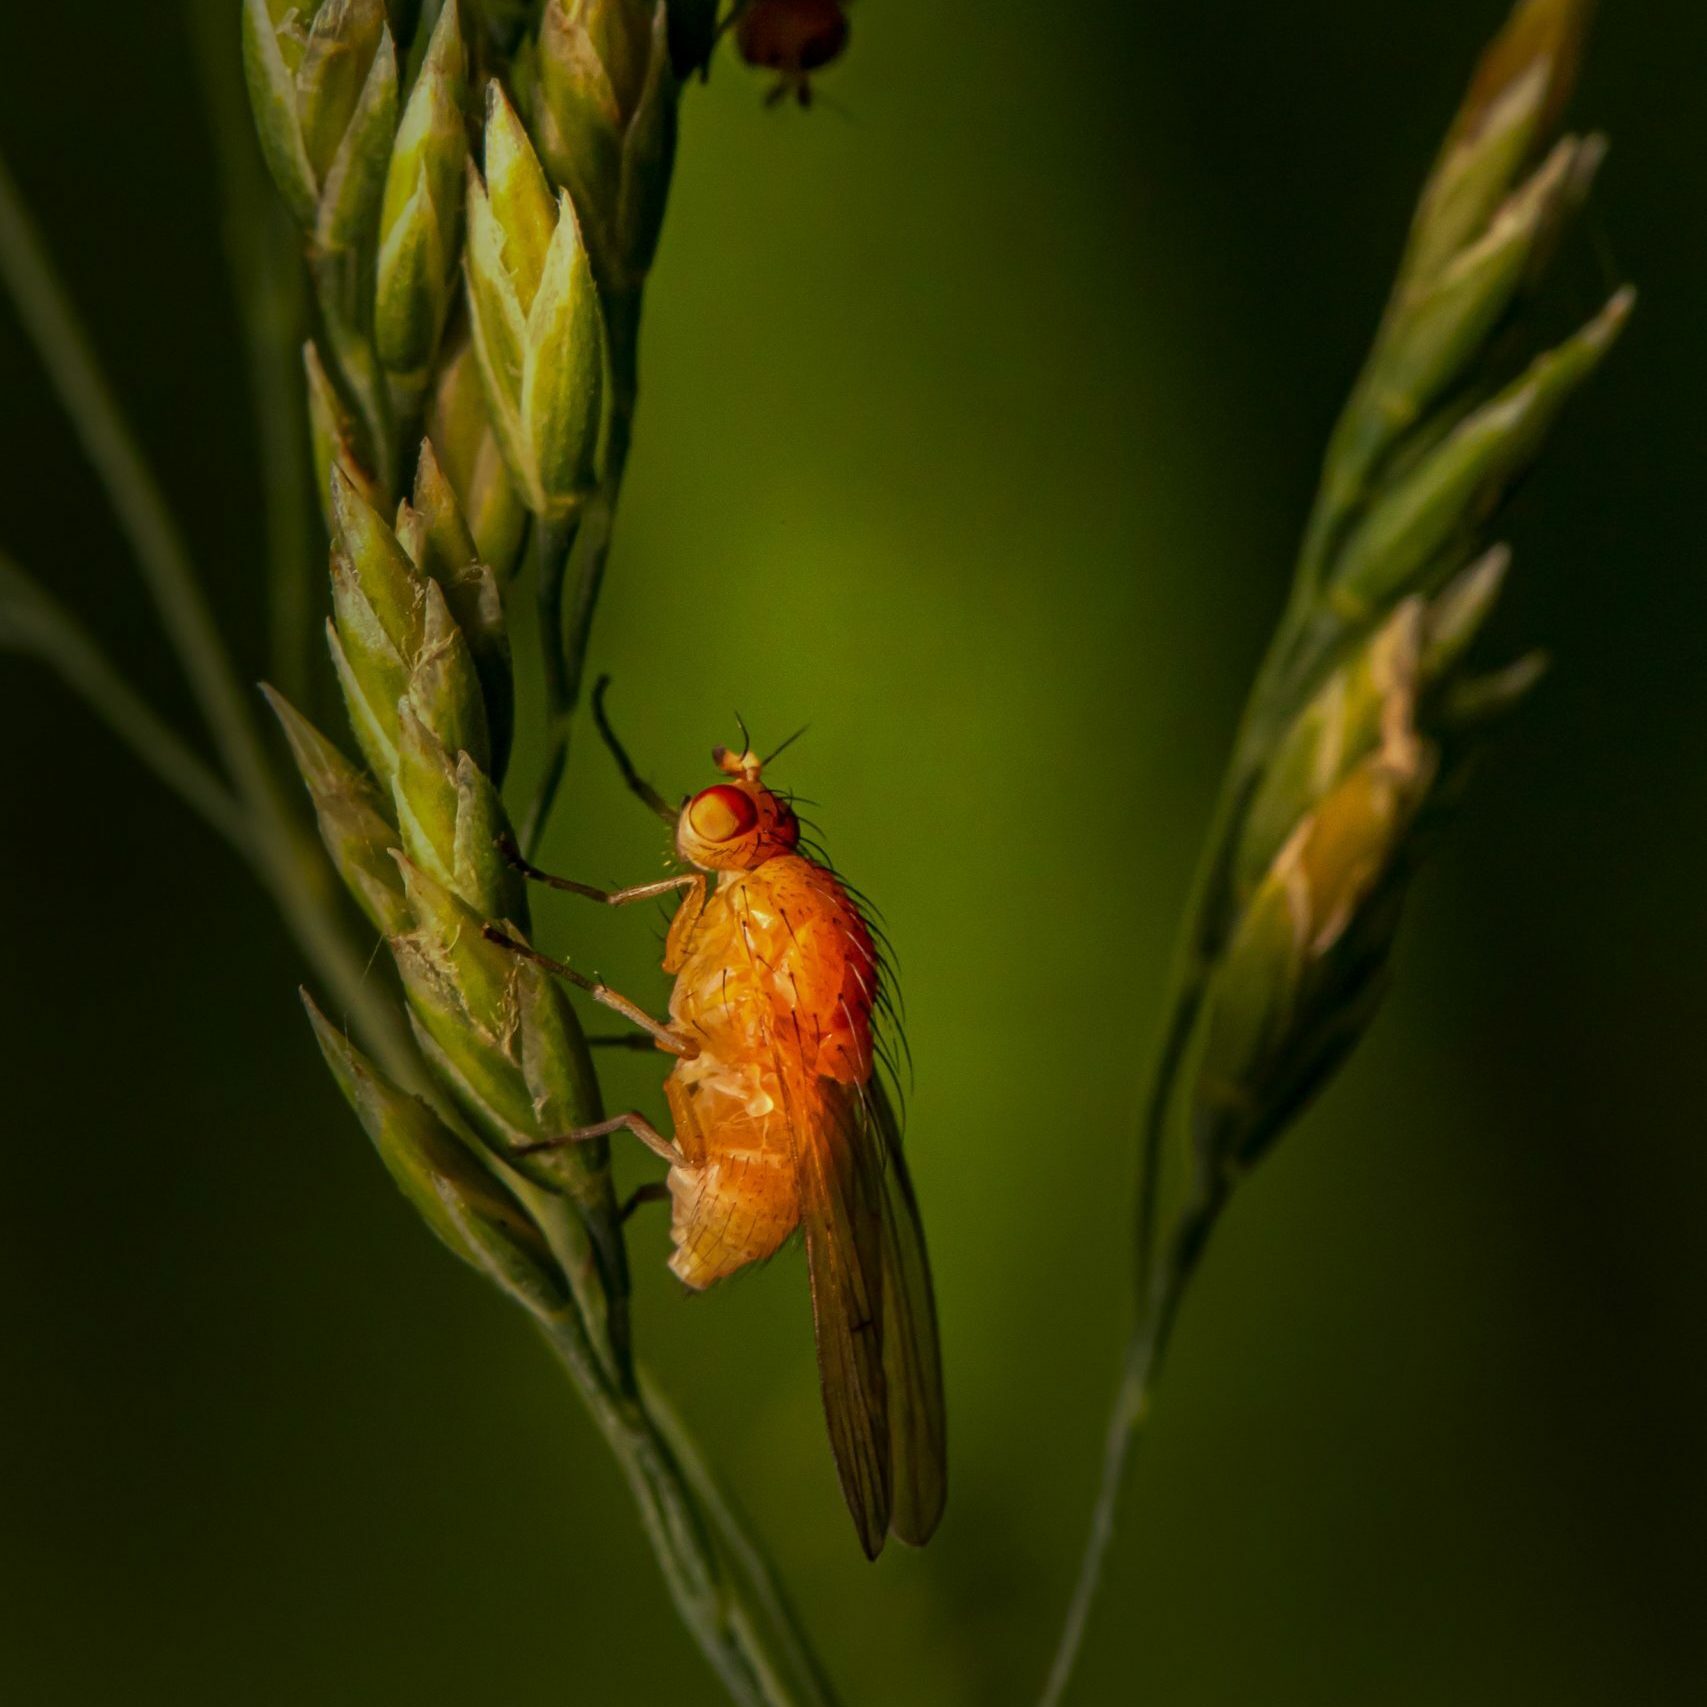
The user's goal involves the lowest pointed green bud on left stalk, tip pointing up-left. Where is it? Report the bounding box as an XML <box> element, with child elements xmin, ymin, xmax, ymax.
<box><xmin>302</xmin><ymin>990</ymin><xmax>565</xmax><ymax>1311</ymax></box>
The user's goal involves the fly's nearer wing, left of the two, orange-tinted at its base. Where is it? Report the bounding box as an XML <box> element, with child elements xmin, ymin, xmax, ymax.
<box><xmin>782</xmin><ymin>1072</ymin><xmax>893</xmax><ymax>1558</ymax></box>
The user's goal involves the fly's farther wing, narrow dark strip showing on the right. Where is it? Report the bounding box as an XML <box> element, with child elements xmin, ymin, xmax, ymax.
<box><xmin>860</xmin><ymin>1074</ymin><xmax>949</xmax><ymax>1547</ymax></box>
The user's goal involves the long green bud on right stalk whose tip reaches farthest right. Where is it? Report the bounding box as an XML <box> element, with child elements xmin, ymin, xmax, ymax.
<box><xmin>1330</xmin><ymin>290</ymin><xmax>1635</xmax><ymax>623</ymax></box>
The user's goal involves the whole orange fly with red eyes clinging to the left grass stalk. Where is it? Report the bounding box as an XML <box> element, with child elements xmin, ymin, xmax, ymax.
<box><xmin>490</xmin><ymin>710</ymin><xmax>947</xmax><ymax>1558</ymax></box>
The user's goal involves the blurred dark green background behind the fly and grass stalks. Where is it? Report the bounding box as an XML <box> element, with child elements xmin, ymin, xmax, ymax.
<box><xmin>0</xmin><ymin>0</ymin><xmax>1707</xmax><ymax>1707</ymax></box>
